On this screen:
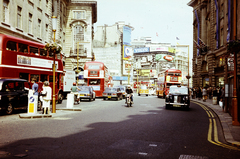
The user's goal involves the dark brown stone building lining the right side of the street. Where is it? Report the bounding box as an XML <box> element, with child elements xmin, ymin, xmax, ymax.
<box><xmin>188</xmin><ymin>0</ymin><xmax>240</xmax><ymax>122</ymax></box>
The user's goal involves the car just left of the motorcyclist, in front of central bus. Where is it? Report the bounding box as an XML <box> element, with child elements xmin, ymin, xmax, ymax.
<box><xmin>103</xmin><ymin>87</ymin><xmax>123</xmax><ymax>100</ymax></box>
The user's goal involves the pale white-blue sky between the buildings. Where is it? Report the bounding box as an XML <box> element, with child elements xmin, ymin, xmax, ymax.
<box><xmin>94</xmin><ymin>0</ymin><xmax>193</xmax><ymax>57</ymax></box>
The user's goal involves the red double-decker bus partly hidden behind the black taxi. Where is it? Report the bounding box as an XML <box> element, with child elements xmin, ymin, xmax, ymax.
<box><xmin>156</xmin><ymin>69</ymin><xmax>182</xmax><ymax>98</ymax></box>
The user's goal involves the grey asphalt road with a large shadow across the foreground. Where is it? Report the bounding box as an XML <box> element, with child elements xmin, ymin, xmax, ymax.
<box><xmin>0</xmin><ymin>96</ymin><xmax>240</xmax><ymax>159</ymax></box>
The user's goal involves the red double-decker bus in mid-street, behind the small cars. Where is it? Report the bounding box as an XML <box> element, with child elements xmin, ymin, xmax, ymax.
<box><xmin>84</xmin><ymin>61</ymin><xmax>111</xmax><ymax>97</ymax></box>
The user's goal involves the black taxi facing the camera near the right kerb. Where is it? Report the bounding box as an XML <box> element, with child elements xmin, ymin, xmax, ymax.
<box><xmin>165</xmin><ymin>85</ymin><xmax>190</xmax><ymax>109</ymax></box>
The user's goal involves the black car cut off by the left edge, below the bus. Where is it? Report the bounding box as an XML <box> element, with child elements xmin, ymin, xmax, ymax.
<box><xmin>0</xmin><ymin>78</ymin><xmax>29</xmax><ymax>114</ymax></box>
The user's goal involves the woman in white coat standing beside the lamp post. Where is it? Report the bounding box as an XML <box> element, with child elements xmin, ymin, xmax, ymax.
<box><xmin>41</xmin><ymin>81</ymin><xmax>52</xmax><ymax>114</ymax></box>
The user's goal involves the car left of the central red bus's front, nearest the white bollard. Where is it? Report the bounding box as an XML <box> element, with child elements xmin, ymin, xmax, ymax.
<box><xmin>78</xmin><ymin>86</ymin><xmax>96</xmax><ymax>101</ymax></box>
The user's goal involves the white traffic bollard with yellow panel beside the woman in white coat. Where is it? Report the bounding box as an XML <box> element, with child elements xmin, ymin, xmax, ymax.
<box><xmin>28</xmin><ymin>89</ymin><xmax>38</xmax><ymax>114</ymax></box>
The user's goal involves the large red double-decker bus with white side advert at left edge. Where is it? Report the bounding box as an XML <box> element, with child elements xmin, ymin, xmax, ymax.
<box><xmin>0</xmin><ymin>34</ymin><xmax>63</xmax><ymax>103</ymax></box>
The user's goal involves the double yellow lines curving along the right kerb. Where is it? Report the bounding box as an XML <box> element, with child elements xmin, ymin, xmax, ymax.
<box><xmin>192</xmin><ymin>101</ymin><xmax>240</xmax><ymax>151</ymax></box>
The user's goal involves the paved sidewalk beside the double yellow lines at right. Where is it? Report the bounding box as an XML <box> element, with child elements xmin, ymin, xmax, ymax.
<box><xmin>191</xmin><ymin>99</ymin><xmax>240</xmax><ymax>146</ymax></box>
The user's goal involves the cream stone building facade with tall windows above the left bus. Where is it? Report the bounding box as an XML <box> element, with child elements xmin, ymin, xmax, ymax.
<box><xmin>0</xmin><ymin>0</ymin><xmax>97</xmax><ymax>75</ymax></box>
